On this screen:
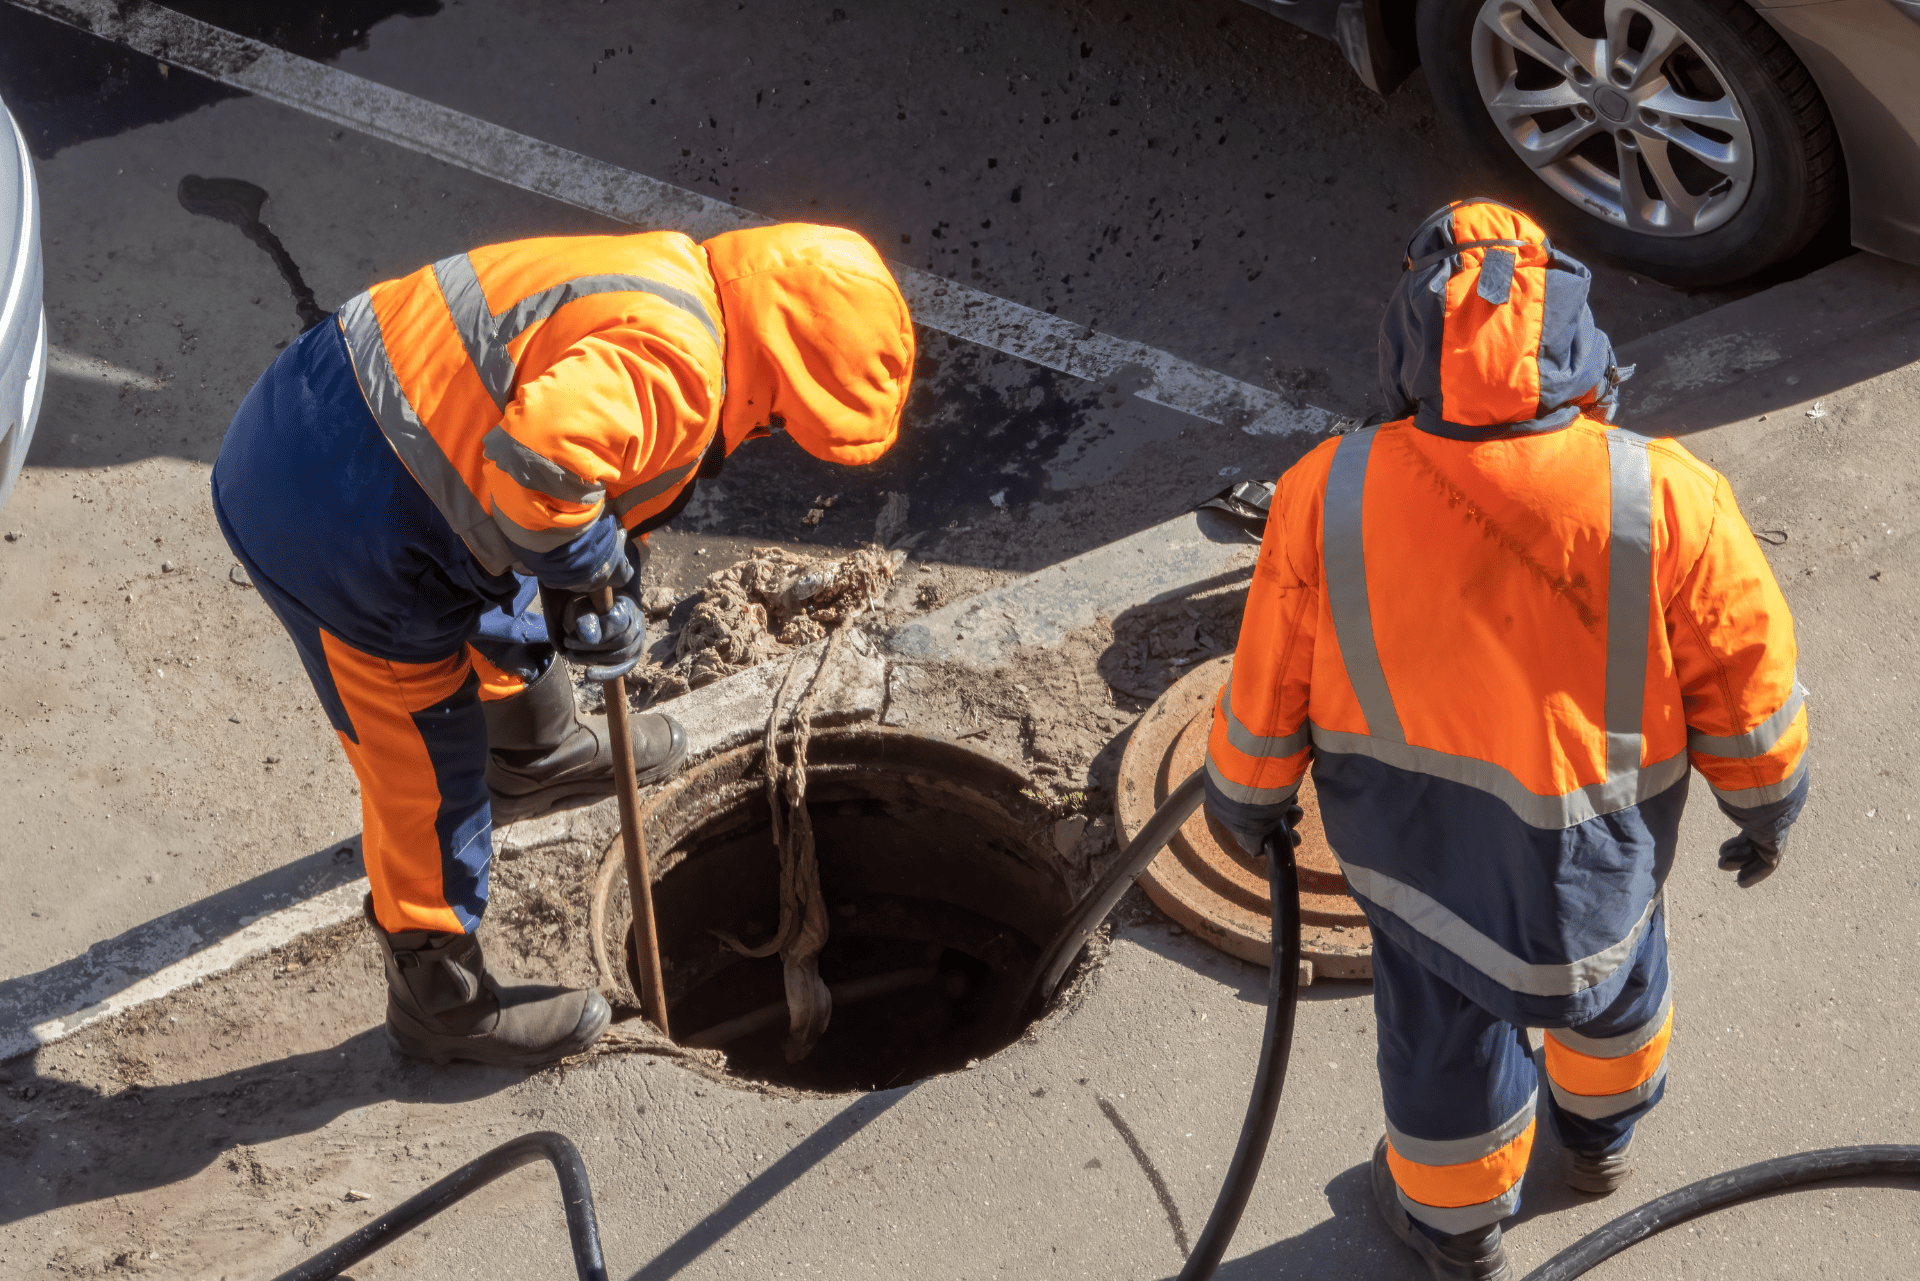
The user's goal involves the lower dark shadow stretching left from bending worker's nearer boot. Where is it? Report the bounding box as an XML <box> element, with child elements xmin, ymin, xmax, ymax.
<box><xmin>0</xmin><ymin>1027</ymin><xmax>528</xmax><ymax>1223</ymax></box>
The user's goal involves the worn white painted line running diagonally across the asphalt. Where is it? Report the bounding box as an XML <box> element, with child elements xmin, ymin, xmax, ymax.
<box><xmin>10</xmin><ymin>0</ymin><xmax>1338</xmax><ymax>436</ymax></box>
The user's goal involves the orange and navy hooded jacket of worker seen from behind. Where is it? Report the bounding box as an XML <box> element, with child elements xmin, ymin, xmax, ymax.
<box><xmin>1208</xmin><ymin>205</ymin><xmax>1807</xmax><ymax>1026</ymax></box>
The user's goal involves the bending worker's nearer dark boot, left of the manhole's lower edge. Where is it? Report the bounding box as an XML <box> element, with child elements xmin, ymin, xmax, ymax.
<box><xmin>365</xmin><ymin>895</ymin><xmax>612</xmax><ymax>1068</ymax></box>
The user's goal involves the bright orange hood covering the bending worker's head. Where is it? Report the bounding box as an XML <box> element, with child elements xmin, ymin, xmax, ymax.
<box><xmin>701</xmin><ymin>223</ymin><xmax>914</xmax><ymax>465</ymax></box>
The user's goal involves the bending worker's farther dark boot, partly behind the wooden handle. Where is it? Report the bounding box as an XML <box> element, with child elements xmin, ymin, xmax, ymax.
<box><xmin>480</xmin><ymin>659</ymin><xmax>687</xmax><ymax>828</ymax></box>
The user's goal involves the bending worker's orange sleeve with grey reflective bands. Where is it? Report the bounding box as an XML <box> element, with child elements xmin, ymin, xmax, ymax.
<box><xmin>486</xmin><ymin>330</ymin><xmax>714</xmax><ymax>586</ymax></box>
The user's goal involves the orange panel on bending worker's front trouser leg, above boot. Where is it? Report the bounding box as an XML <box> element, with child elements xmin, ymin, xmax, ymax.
<box><xmin>321</xmin><ymin>632</ymin><xmax>486</xmax><ymax>933</ymax></box>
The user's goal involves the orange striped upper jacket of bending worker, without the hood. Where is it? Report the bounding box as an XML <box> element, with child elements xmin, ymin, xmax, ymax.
<box><xmin>340</xmin><ymin>232</ymin><xmax>721</xmax><ymax>574</ymax></box>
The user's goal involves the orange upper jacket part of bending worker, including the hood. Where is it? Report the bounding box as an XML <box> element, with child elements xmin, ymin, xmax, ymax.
<box><xmin>340</xmin><ymin>223</ymin><xmax>914</xmax><ymax>574</ymax></box>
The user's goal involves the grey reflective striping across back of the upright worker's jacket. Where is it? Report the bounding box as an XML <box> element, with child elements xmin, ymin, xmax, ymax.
<box><xmin>1311</xmin><ymin>428</ymin><xmax>1688</xmax><ymax>995</ymax></box>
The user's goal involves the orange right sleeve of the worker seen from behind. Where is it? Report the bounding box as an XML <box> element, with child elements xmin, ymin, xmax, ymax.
<box><xmin>1667</xmin><ymin>478</ymin><xmax>1809</xmax><ymax>839</ymax></box>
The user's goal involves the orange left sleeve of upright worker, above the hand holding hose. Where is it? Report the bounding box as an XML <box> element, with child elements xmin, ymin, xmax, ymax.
<box><xmin>1206</xmin><ymin>469</ymin><xmax>1319</xmax><ymax>832</ymax></box>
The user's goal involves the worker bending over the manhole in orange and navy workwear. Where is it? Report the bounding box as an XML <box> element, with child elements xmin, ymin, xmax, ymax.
<box><xmin>213</xmin><ymin>225</ymin><xmax>914</xmax><ymax>1066</ymax></box>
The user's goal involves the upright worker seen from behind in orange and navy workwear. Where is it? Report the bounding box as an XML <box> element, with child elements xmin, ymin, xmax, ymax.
<box><xmin>1206</xmin><ymin>200</ymin><xmax>1807</xmax><ymax>1277</ymax></box>
